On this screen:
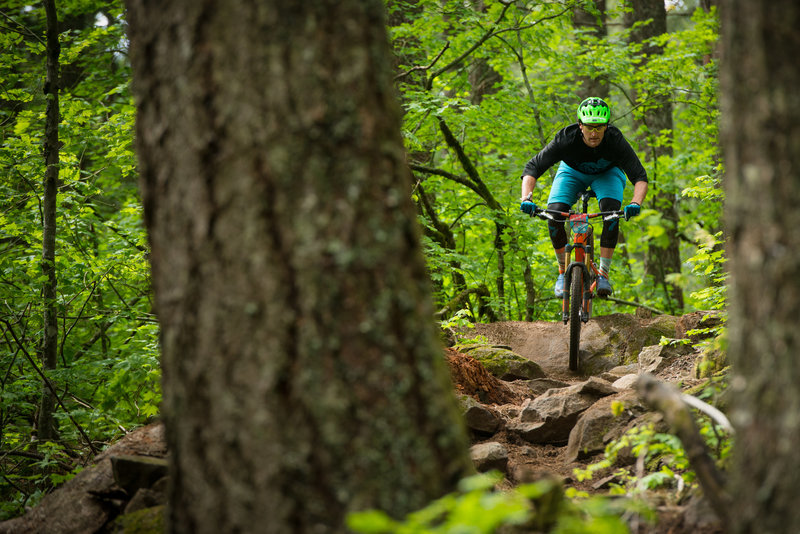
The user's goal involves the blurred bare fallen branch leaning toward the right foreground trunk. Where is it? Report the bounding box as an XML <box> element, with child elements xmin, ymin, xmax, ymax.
<box><xmin>636</xmin><ymin>374</ymin><xmax>731</xmax><ymax>532</ymax></box>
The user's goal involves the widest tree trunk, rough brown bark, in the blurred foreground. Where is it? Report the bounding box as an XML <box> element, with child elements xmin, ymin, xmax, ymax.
<box><xmin>128</xmin><ymin>0</ymin><xmax>469</xmax><ymax>534</ymax></box>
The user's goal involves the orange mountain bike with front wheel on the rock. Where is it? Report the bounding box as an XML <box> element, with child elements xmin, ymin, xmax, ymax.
<box><xmin>533</xmin><ymin>189</ymin><xmax>625</xmax><ymax>371</ymax></box>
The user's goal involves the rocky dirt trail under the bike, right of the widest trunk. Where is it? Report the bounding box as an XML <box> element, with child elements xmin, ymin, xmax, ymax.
<box><xmin>447</xmin><ymin>313</ymin><xmax>722</xmax><ymax>534</ymax></box>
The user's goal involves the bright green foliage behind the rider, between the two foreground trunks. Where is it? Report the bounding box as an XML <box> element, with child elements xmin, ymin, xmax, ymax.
<box><xmin>389</xmin><ymin>1</ymin><xmax>721</xmax><ymax>319</ymax></box>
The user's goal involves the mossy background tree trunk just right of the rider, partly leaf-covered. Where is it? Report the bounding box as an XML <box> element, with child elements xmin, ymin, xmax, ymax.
<box><xmin>627</xmin><ymin>0</ymin><xmax>683</xmax><ymax>313</ymax></box>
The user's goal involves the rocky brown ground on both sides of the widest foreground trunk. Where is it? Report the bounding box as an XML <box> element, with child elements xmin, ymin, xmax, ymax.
<box><xmin>0</xmin><ymin>313</ymin><xmax>722</xmax><ymax>534</ymax></box>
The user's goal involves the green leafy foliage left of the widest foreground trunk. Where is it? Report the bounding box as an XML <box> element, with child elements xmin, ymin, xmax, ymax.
<box><xmin>0</xmin><ymin>0</ymin><xmax>160</xmax><ymax>516</ymax></box>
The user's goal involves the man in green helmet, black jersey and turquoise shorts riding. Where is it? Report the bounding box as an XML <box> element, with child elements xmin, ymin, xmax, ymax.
<box><xmin>520</xmin><ymin>97</ymin><xmax>647</xmax><ymax>298</ymax></box>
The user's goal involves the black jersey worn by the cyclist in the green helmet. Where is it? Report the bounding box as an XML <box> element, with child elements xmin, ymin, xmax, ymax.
<box><xmin>523</xmin><ymin>123</ymin><xmax>647</xmax><ymax>184</ymax></box>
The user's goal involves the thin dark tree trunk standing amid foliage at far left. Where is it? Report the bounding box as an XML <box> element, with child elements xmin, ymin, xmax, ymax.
<box><xmin>37</xmin><ymin>0</ymin><xmax>61</xmax><ymax>440</ymax></box>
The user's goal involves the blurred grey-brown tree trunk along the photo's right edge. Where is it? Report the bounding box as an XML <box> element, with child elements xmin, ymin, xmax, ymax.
<box><xmin>721</xmin><ymin>0</ymin><xmax>800</xmax><ymax>533</ymax></box>
